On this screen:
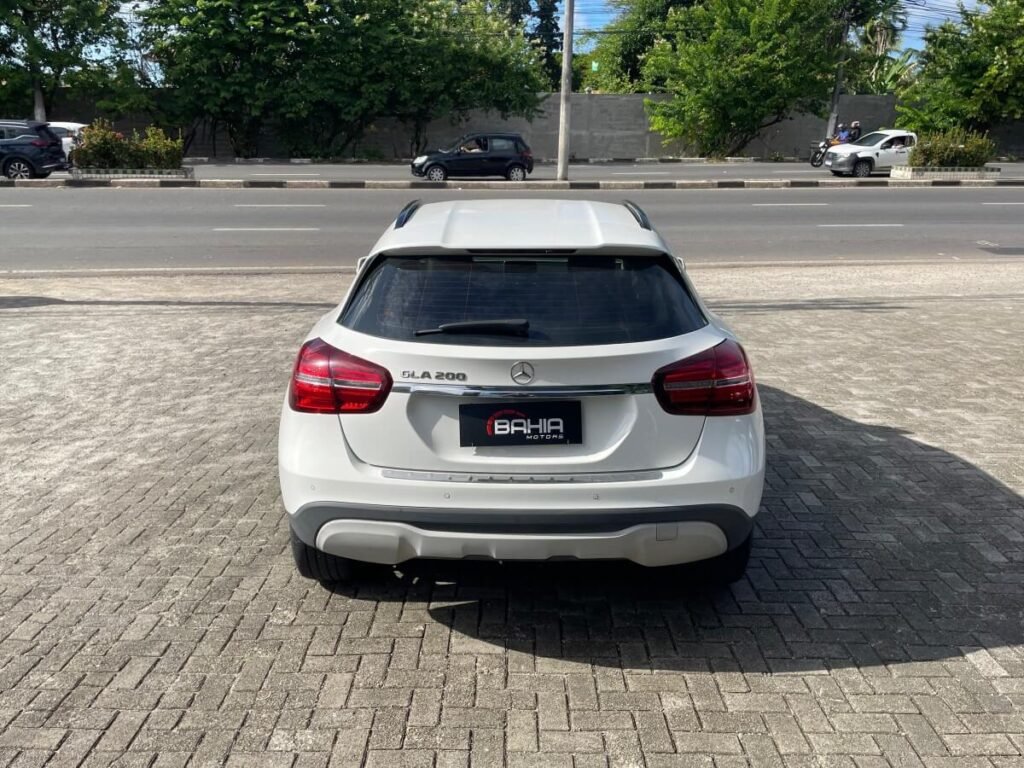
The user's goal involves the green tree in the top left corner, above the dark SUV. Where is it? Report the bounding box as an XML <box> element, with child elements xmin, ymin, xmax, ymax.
<box><xmin>0</xmin><ymin>0</ymin><xmax>125</xmax><ymax>120</ymax></box>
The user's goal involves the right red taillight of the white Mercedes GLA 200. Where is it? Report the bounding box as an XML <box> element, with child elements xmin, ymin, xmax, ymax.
<box><xmin>652</xmin><ymin>339</ymin><xmax>757</xmax><ymax>416</ymax></box>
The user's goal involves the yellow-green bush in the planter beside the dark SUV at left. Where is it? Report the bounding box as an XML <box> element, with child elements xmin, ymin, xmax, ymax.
<box><xmin>72</xmin><ymin>120</ymin><xmax>184</xmax><ymax>169</ymax></box>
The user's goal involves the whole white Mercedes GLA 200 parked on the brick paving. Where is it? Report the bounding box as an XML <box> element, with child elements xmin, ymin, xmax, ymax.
<box><xmin>279</xmin><ymin>200</ymin><xmax>765</xmax><ymax>582</ymax></box>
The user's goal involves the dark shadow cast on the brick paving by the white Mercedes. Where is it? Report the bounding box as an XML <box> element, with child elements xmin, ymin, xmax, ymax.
<box><xmin>327</xmin><ymin>385</ymin><xmax>1024</xmax><ymax>675</ymax></box>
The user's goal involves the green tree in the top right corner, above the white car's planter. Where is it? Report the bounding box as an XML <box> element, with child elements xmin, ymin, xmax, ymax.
<box><xmin>897</xmin><ymin>0</ymin><xmax>1024</xmax><ymax>131</ymax></box>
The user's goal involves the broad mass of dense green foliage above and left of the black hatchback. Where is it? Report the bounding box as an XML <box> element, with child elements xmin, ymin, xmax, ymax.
<box><xmin>146</xmin><ymin>0</ymin><xmax>544</xmax><ymax>156</ymax></box>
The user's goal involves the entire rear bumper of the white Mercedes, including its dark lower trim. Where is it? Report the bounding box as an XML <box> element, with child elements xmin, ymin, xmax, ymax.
<box><xmin>279</xmin><ymin>404</ymin><xmax>765</xmax><ymax>565</ymax></box>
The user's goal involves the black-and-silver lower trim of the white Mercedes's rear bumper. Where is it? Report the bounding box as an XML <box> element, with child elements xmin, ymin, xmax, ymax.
<box><xmin>291</xmin><ymin>503</ymin><xmax>754</xmax><ymax>566</ymax></box>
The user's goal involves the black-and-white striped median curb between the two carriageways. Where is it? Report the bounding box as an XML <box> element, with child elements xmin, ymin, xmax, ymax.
<box><xmin>8</xmin><ymin>178</ymin><xmax>1024</xmax><ymax>191</ymax></box>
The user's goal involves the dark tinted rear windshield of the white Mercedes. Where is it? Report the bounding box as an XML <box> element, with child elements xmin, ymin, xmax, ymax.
<box><xmin>339</xmin><ymin>254</ymin><xmax>707</xmax><ymax>346</ymax></box>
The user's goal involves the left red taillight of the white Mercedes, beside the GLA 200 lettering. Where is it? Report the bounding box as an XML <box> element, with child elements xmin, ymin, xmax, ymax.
<box><xmin>288</xmin><ymin>339</ymin><xmax>391</xmax><ymax>414</ymax></box>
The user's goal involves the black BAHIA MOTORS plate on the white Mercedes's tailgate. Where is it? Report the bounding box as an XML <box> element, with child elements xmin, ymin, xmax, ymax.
<box><xmin>459</xmin><ymin>400</ymin><xmax>583</xmax><ymax>446</ymax></box>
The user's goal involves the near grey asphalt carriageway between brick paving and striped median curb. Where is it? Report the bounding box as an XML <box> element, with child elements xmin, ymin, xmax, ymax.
<box><xmin>0</xmin><ymin>187</ymin><xmax>1024</xmax><ymax>270</ymax></box>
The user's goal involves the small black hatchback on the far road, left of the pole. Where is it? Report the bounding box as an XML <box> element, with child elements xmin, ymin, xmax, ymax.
<box><xmin>413</xmin><ymin>133</ymin><xmax>534</xmax><ymax>181</ymax></box>
